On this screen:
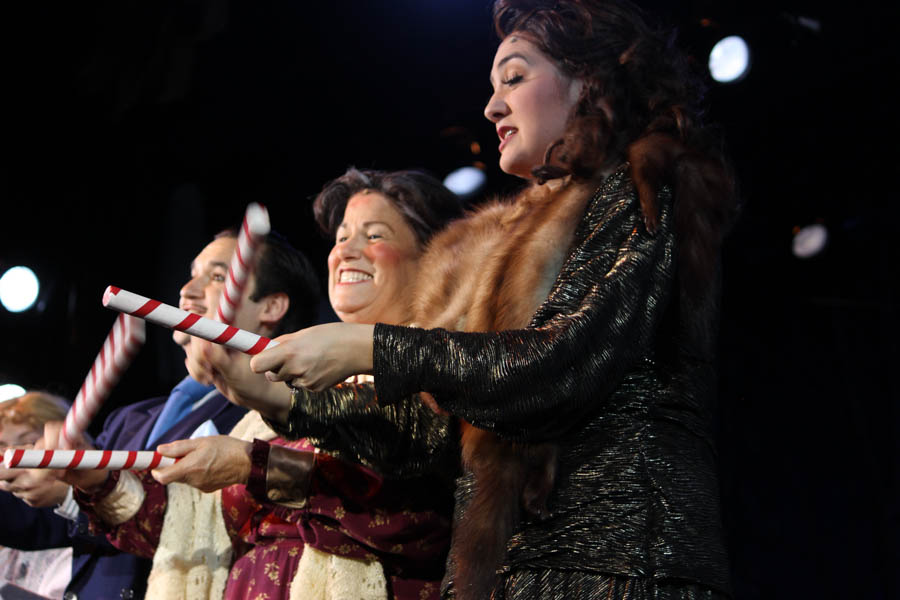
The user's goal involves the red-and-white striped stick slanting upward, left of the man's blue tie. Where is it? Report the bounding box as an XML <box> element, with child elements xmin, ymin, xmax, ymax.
<box><xmin>61</xmin><ymin>315</ymin><xmax>146</xmax><ymax>448</ymax></box>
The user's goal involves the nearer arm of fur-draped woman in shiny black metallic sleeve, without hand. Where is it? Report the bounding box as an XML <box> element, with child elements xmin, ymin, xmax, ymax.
<box><xmin>373</xmin><ymin>185</ymin><xmax>675</xmax><ymax>441</ymax></box>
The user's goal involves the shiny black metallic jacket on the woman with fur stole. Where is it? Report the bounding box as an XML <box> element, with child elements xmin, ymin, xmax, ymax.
<box><xmin>268</xmin><ymin>169</ymin><xmax>729</xmax><ymax>592</ymax></box>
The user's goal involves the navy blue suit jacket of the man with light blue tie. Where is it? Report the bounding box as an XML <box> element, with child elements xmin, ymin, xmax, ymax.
<box><xmin>0</xmin><ymin>393</ymin><xmax>246</xmax><ymax>600</ymax></box>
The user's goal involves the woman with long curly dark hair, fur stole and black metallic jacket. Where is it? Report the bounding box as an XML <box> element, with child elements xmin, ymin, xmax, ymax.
<box><xmin>243</xmin><ymin>0</ymin><xmax>735</xmax><ymax>599</ymax></box>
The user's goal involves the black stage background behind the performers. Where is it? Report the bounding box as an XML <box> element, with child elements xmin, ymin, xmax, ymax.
<box><xmin>0</xmin><ymin>0</ymin><xmax>900</xmax><ymax>598</ymax></box>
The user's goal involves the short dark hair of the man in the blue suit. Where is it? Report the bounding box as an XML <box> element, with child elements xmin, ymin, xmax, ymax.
<box><xmin>215</xmin><ymin>227</ymin><xmax>322</xmax><ymax>337</ymax></box>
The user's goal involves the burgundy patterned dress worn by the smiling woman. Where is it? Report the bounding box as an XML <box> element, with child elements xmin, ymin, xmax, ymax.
<box><xmin>82</xmin><ymin>438</ymin><xmax>452</xmax><ymax>600</ymax></box>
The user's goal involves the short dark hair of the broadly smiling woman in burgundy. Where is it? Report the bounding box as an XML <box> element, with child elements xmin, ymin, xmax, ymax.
<box><xmin>313</xmin><ymin>167</ymin><xmax>462</xmax><ymax>246</ymax></box>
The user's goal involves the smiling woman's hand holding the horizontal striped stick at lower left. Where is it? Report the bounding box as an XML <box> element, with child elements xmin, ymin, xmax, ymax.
<box><xmin>152</xmin><ymin>435</ymin><xmax>252</xmax><ymax>492</ymax></box>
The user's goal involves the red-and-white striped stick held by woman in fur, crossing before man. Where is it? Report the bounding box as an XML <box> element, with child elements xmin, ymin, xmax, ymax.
<box><xmin>103</xmin><ymin>286</ymin><xmax>278</xmax><ymax>355</ymax></box>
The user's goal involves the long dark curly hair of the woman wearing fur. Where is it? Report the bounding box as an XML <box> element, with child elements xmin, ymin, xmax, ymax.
<box><xmin>494</xmin><ymin>0</ymin><xmax>736</xmax><ymax>297</ymax></box>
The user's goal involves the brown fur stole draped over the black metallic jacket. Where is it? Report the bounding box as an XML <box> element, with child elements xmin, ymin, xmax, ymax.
<box><xmin>413</xmin><ymin>180</ymin><xmax>597</xmax><ymax>600</ymax></box>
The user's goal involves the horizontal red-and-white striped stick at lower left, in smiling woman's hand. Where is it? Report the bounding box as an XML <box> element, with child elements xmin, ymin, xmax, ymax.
<box><xmin>3</xmin><ymin>448</ymin><xmax>175</xmax><ymax>470</ymax></box>
